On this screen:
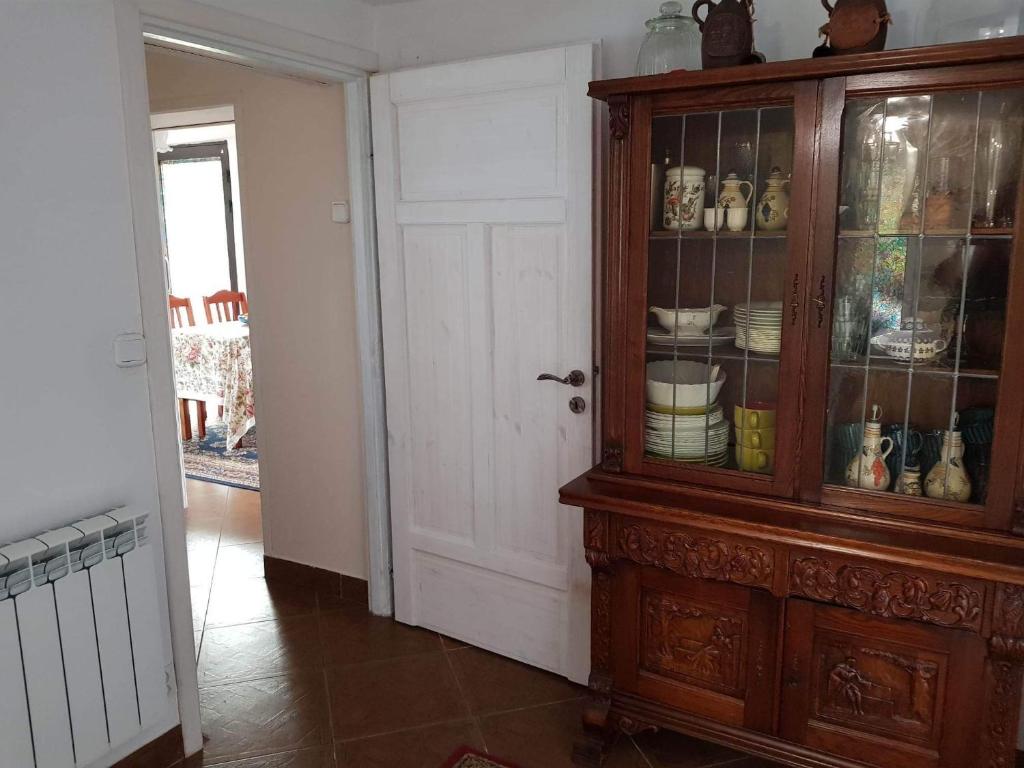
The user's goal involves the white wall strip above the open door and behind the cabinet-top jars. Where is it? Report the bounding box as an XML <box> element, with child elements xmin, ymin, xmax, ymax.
<box><xmin>375</xmin><ymin>0</ymin><xmax>1021</xmax><ymax>77</ymax></box>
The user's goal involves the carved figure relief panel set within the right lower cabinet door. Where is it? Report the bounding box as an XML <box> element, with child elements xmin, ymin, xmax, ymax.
<box><xmin>812</xmin><ymin>633</ymin><xmax>948</xmax><ymax>749</ymax></box>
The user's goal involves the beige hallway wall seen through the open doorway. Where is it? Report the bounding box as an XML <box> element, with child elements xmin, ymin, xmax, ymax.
<box><xmin>146</xmin><ymin>48</ymin><xmax>367</xmax><ymax>579</ymax></box>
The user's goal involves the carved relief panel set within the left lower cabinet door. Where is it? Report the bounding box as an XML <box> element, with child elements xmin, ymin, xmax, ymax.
<box><xmin>640</xmin><ymin>589</ymin><xmax>746</xmax><ymax>697</ymax></box>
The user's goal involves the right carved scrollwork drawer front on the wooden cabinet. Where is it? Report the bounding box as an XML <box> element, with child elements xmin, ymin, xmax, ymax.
<box><xmin>790</xmin><ymin>557</ymin><xmax>985</xmax><ymax>632</ymax></box>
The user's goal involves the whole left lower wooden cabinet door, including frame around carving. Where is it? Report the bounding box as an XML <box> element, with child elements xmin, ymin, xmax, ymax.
<box><xmin>612</xmin><ymin>563</ymin><xmax>778</xmax><ymax>731</ymax></box>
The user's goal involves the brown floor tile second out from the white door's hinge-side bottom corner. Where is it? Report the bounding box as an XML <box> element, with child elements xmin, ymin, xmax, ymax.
<box><xmin>327</xmin><ymin>653</ymin><xmax>469</xmax><ymax>740</ymax></box>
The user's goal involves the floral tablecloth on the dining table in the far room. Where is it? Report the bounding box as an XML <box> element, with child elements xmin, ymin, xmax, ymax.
<box><xmin>172</xmin><ymin>322</ymin><xmax>256</xmax><ymax>451</ymax></box>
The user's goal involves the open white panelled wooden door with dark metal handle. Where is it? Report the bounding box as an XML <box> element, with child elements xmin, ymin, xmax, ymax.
<box><xmin>371</xmin><ymin>45</ymin><xmax>595</xmax><ymax>681</ymax></box>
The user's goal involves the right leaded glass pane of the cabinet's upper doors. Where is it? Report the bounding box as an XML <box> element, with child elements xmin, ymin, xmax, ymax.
<box><xmin>824</xmin><ymin>89</ymin><xmax>1024</xmax><ymax>520</ymax></box>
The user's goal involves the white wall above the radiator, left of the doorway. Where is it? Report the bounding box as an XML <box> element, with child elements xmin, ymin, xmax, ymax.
<box><xmin>0</xmin><ymin>0</ymin><xmax>179</xmax><ymax>762</ymax></box>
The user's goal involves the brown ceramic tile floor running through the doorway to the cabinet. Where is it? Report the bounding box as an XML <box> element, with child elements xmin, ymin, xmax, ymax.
<box><xmin>178</xmin><ymin>480</ymin><xmax>772</xmax><ymax>768</ymax></box>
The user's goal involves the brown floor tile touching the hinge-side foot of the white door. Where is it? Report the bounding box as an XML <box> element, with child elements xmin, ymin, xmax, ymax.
<box><xmin>319</xmin><ymin>604</ymin><xmax>441</xmax><ymax>666</ymax></box>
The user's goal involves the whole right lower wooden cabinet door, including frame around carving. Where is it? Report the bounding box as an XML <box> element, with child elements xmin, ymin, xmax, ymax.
<box><xmin>780</xmin><ymin>600</ymin><xmax>985</xmax><ymax>768</ymax></box>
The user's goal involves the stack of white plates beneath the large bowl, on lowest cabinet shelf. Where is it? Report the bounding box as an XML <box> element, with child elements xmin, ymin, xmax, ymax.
<box><xmin>644</xmin><ymin>403</ymin><xmax>729</xmax><ymax>467</ymax></box>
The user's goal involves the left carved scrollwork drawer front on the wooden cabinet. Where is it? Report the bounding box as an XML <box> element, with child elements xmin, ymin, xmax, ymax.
<box><xmin>618</xmin><ymin>522</ymin><xmax>773</xmax><ymax>588</ymax></box>
